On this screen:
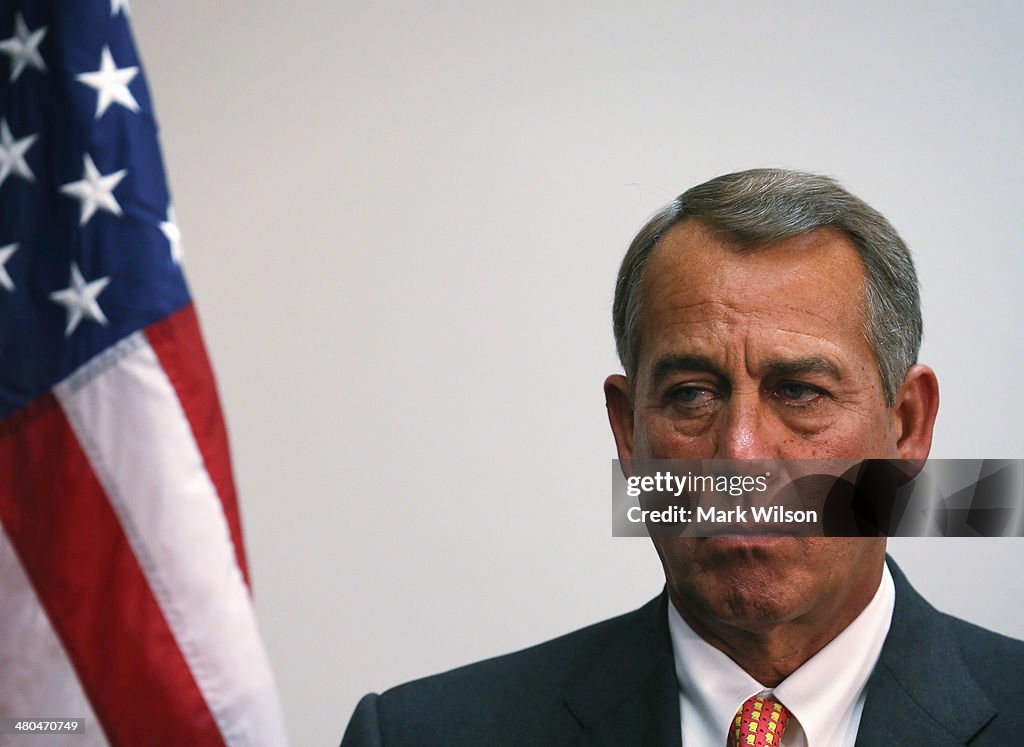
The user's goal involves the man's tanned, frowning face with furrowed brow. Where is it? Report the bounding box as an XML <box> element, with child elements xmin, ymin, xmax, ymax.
<box><xmin>609</xmin><ymin>220</ymin><xmax>901</xmax><ymax>631</ymax></box>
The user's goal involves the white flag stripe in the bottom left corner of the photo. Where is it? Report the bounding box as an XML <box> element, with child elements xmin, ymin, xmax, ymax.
<box><xmin>0</xmin><ymin>525</ymin><xmax>109</xmax><ymax>747</ymax></box>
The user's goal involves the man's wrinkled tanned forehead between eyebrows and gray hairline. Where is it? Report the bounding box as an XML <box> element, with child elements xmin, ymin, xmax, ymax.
<box><xmin>640</xmin><ymin>220</ymin><xmax>873</xmax><ymax>370</ymax></box>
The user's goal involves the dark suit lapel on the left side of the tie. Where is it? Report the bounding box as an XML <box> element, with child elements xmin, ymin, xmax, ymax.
<box><xmin>565</xmin><ymin>592</ymin><xmax>682</xmax><ymax>747</ymax></box>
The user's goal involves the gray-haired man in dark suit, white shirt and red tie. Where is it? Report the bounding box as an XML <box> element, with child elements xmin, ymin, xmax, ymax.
<box><xmin>342</xmin><ymin>170</ymin><xmax>1024</xmax><ymax>747</ymax></box>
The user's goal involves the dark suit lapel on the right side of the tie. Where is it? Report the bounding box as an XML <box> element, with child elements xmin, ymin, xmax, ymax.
<box><xmin>857</xmin><ymin>558</ymin><xmax>995</xmax><ymax>747</ymax></box>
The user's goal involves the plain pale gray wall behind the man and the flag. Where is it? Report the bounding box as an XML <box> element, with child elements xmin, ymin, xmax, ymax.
<box><xmin>132</xmin><ymin>0</ymin><xmax>1024</xmax><ymax>745</ymax></box>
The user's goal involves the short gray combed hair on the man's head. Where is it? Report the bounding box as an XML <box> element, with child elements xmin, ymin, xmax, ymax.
<box><xmin>612</xmin><ymin>169</ymin><xmax>922</xmax><ymax>407</ymax></box>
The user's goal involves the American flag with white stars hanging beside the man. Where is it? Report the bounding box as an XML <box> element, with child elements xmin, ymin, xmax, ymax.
<box><xmin>0</xmin><ymin>0</ymin><xmax>286</xmax><ymax>746</ymax></box>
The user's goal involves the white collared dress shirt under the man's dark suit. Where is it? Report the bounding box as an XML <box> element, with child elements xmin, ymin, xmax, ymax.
<box><xmin>669</xmin><ymin>567</ymin><xmax>896</xmax><ymax>747</ymax></box>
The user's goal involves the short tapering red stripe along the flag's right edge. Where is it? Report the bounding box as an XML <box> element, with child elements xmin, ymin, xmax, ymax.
<box><xmin>145</xmin><ymin>304</ymin><xmax>249</xmax><ymax>585</ymax></box>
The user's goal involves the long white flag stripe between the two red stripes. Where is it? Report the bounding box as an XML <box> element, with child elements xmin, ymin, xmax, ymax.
<box><xmin>54</xmin><ymin>333</ymin><xmax>287</xmax><ymax>747</ymax></box>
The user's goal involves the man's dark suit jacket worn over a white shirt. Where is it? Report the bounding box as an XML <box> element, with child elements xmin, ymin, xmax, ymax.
<box><xmin>341</xmin><ymin>559</ymin><xmax>1024</xmax><ymax>747</ymax></box>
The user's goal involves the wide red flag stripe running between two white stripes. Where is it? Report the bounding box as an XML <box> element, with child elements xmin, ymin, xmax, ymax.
<box><xmin>0</xmin><ymin>395</ymin><xmax>224</xmax><ymax>747</ymax></box>
